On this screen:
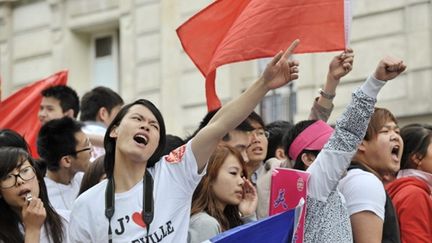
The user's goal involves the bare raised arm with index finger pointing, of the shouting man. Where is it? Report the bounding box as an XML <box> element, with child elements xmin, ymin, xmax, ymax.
<box><xmin>192</xmin><ymin>40</ymin><xmax>299</xmax><ymax>172</ymax></box>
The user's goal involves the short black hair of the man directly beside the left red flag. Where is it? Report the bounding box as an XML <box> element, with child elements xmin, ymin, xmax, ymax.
<box><xmin>41</xmin><ymin>85</ymin><xmax>80</xmax><ymax>118</ymax></box>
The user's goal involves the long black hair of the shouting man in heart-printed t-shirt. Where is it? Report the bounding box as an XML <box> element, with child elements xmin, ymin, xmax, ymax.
<box><xmin>104</xmin><ymin>99</ymin><xmax>166</xmax><ymax>178</ymax></box>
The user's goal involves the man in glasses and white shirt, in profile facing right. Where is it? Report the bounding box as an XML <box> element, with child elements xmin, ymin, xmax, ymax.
<box><xmin>37</xmin><ymin>117</ymin><xmax>92</xmax><ymax>212</ymax></box>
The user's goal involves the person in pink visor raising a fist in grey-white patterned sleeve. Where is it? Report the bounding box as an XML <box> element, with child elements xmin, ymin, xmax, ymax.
<box><xmin>260</xmin><ymin>58</ymin><xmax>405</xmax><ymax>242</ymax></box>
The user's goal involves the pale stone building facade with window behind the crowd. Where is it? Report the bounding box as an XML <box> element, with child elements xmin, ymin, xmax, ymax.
<box><xmin>0</xmin><ymin>0</ymin><xmax>432</xmax><ymax>136</ymax></box>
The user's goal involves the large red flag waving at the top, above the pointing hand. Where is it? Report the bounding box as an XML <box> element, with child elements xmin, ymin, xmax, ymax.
<box><xmin>177</xmin><ymin>0</ymin><xmax>350</xmax><ymax>110</ymax></box>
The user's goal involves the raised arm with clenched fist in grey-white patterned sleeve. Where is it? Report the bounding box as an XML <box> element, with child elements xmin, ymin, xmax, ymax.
<box><xmin>308</xmin><ymin>57</ymin><xmax>406</xmax><ymax>201</ymax></box>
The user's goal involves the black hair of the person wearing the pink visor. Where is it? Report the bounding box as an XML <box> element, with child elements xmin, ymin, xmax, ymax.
<box><xmin>282</xmin><ymin>120</ymin><xmax>319</xmax><ymax>170</ymax></box>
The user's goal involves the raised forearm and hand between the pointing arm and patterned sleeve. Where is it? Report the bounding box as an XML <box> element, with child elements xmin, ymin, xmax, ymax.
<box><xmin>309</xmin><ymin>48</ymin><xmax>354</xmax><ymax>121</ymax></box>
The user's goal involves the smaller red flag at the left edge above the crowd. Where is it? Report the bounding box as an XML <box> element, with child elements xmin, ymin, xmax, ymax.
<box><xmin>0</xmin><ymin>71</ymin><xmax>68</xmax><ymax>157</ymax></box>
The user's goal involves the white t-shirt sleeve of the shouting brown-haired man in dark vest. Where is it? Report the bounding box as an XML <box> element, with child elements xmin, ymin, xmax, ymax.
<box><xmin>339</xmin><ymin>169</ymin><xmax>386</xmax><ymax>220</ymax></box>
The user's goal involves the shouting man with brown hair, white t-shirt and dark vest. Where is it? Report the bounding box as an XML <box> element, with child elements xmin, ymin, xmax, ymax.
<box><xmin>339</xmin><ymin>108</ymin><xmax>403</xmax><ymax>242</ymax></box>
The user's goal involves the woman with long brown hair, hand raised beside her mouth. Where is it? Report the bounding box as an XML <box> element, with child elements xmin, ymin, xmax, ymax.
<box><xmin>188</xmin><ymin>146</ymin><xmax>258</xmax><ymax>243</ymax></box>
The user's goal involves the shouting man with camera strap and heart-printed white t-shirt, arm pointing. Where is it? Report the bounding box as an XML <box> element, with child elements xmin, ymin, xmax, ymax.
<box><xmin>69</xmin><ymin>41</ymin><xmax>298</xmax><ymax>243</ymax></box>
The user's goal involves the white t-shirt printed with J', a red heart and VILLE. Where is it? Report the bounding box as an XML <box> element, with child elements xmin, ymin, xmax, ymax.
<box><xmin>69</xmin><ymin>142</ymin><xmax>205</xmax><ymax>243</ymax></box>
